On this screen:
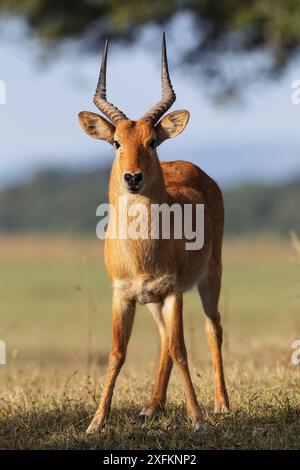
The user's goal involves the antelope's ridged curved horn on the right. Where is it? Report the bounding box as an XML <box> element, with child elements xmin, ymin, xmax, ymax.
<box><xmin>143</xmin><ymin>33</ymin><xmax>176</xmax><ymax>123</ymax></box>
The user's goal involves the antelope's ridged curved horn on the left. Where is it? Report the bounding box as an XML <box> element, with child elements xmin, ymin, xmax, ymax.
<box><xmin>93</xmin><ymin>39</ymin><xmax>127</xmax><ymax>125</ymax></box>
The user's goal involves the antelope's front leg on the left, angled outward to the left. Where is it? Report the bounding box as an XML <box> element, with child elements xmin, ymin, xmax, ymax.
<box><xmin>86</xmin><ymin>289</ymin><xmax>135</xmax><ymax>434</ymax></box>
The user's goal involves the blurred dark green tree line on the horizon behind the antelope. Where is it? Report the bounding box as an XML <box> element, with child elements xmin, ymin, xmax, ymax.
<box><xmin>0</xmin><ymin>167</ymin><xmax>300</xmax><ymax>236</ymax></box>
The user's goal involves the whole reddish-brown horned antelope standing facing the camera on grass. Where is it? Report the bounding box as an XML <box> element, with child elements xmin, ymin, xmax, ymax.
<box><xmin>79</xmin><ymin>35</ymin><xmax>229</xmax><ymax>433</ymax></box>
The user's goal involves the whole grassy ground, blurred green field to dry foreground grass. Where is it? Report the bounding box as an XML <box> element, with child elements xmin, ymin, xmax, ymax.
<box><xmin>0</xmin><ymin>237</ymin><xmax>300</xmax><ymax>449</ymax></box>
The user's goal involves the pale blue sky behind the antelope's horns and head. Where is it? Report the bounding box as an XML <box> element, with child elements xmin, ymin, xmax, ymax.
<box><xmin>0</xmin><ymin>18</ymin><xmax>300</xmax><ymax>188</ymax></box>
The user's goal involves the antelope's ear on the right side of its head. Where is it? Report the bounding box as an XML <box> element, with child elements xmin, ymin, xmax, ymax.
<box><xmin>155</xmin><ymin>109</ymin><xmax>190</xmax><ymax>144</ymax></box>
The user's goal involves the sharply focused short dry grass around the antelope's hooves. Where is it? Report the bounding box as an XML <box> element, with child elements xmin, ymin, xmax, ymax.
<box><xmin>0</xmin><ymin>367</ymin><xmax>300</xmax><ymax>449</ymax></box>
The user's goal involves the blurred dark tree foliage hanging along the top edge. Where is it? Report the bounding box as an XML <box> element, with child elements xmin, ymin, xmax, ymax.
<box><xmin>0</xmin><ymin>0</ymin><xmax>300</xmax><ymax>96</ymax></box>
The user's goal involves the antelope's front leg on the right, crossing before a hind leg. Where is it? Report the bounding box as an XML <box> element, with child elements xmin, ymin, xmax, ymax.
<box><xmin>163</xmin><ymin>293</ymin><xmax>203</xmax><ymax>429</ymax></box>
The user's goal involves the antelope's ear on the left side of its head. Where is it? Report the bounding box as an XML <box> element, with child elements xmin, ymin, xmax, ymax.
<box><xmin>78</xmin><ymin>111</ymin><xmax>116</xmax><ymax>144</ymax></box>
